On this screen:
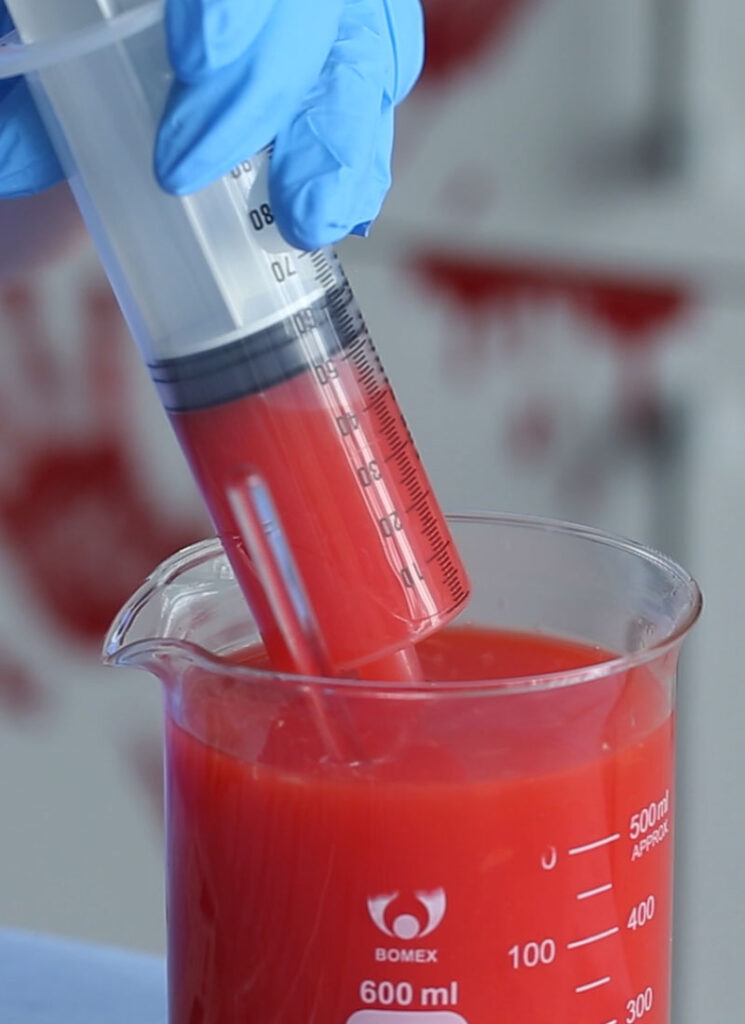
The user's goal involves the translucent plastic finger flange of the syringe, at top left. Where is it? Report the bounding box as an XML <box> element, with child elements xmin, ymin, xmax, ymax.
<box><xmin>0</xmin><ymin>0</ymin><xmax>166</xmax><ymax>80</ymax></box>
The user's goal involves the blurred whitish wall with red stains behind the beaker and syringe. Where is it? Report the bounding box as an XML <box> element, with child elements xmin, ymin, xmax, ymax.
<box><xmin>0</xmin><ymin>0</ymin><xmax>745</xmax><ymax>1024</ymax></box>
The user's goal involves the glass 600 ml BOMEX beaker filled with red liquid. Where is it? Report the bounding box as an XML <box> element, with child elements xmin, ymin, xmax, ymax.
<box><xmin>105</xmin><ymin>516</ymin><xmax>701</xmax><ymax>1024</ymax></box>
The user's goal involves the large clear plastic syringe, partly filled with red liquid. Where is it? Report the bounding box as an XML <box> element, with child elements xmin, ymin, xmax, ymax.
<box><xmin>0</xmin><ymin>0</ymin><xmax>468</xmax><ymax>678</ymax></box>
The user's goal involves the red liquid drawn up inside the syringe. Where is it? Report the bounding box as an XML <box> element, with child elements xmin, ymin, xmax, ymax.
<box><xmin>159</xmin><ymin>280</ymin><xmax>468</xmax><ymax>679</ymax></box>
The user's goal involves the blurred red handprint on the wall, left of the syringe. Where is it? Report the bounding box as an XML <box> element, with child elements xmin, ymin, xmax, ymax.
<box><xmin>0</xmin><ymin>284</ymin><xmax>205</xmax><ymax>642</ymax></box>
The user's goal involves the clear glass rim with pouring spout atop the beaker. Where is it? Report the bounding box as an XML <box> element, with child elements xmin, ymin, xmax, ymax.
<box><xmin>103</xmin><ymin>512</ymin><xmax>703</xmax><ymax>699</ymax></box>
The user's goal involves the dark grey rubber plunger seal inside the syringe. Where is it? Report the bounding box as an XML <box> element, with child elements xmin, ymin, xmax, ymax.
<box><xmin>148</xmin><ymin>285</ymin><xmax>364</xmax><ymax>413</ymax></box>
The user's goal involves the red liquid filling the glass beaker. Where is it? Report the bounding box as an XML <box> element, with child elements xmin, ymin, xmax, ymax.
<box><xmin>167</xmin><ymin>629</ymin><xmax>674</xmax><ymax>1024</ymax></box>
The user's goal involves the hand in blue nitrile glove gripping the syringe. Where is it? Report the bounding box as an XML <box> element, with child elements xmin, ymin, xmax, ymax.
<box><xmin>0</xmin><ymin>0</ymin><xmax>424</xmax><ymax>249</ymax></box>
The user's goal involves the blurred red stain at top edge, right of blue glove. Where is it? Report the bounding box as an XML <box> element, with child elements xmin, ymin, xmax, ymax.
<box><xmin>423</xmin><ymin>0</ymin><xmax>535</xmax><ymax>81</ymax></box>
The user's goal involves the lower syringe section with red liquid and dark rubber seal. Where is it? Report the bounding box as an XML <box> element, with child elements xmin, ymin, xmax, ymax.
<box><xmin>162</xmin><ymin>201</ymin><xmax>467</xmax><ymax>677</ymax></box>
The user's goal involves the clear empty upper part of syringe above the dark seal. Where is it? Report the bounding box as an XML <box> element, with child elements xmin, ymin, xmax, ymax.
<box><xmin>7</xmin><ymin>0</ymin><xmax>335</xmax><ymax>364</ymax></box>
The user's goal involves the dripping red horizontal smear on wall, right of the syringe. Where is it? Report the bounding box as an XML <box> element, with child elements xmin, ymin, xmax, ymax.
<box><xmin>412</xmin><ymin>253</ymin><xmax>692</xmax><ymax>462</ymax></box>
